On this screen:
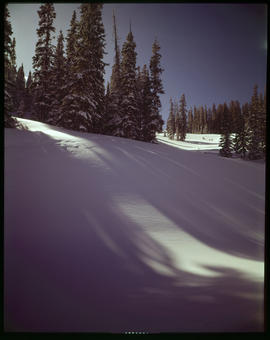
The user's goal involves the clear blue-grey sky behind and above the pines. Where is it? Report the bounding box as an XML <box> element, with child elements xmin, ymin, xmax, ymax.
<box><xmin>8</xmin><ymin>3</ymin><xmax>267</xmax><ymax>120</ymax></box>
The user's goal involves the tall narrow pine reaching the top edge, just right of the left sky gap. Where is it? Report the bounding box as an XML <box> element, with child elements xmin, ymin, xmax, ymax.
<box><xmin>33</xmin><ymin>3</ymin><xmax>56</xmax><ymax>122</ymax></box>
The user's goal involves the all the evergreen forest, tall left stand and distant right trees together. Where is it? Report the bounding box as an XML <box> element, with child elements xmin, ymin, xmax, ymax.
<box><xmin>4</xmin><ymin>3</ymin><xmax>266</xmax><ymax>159</ymax></box>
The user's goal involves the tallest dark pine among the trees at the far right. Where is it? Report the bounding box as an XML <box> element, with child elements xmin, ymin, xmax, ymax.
<box><xmin>248</xmin><ymin>84</ymin><xmax>262</xmax><ymax>160</ymax></box>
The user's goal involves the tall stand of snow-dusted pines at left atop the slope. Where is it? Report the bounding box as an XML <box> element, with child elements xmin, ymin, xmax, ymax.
<box><xmin>4</xmin><ymin>3</ymin><xmax>164</xmax><ymax>142</ymax></box>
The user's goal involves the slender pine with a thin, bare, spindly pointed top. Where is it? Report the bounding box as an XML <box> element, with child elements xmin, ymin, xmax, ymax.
<box><xmin>104</xmin><ymin>12</ymin><xmax>123</xmax><ymax>136</ymax></box>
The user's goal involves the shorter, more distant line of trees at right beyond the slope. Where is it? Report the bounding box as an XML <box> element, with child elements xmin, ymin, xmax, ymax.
<box><xmin>166</xmin><ymin>85</ymin><xmax>266</xmax><ymax>159</ymax></box>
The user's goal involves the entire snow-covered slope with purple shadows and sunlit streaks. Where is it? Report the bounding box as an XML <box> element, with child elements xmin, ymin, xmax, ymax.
<box><xmin>4</xmin><ymin>119</ymin><xmax>265</xmax><ymax>333</ymax></box>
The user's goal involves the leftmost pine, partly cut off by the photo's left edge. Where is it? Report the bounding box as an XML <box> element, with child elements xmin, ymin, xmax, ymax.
<box><xmin>4</xmin><ymin>4</ymin><xmax>17</xmax><ymax>127</ymax></box>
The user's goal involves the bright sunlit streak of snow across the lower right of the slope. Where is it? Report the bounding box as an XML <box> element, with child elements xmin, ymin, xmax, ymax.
<box><xmin>114</xmin><ymin>195</ymin><xmax>264</xmax><ymax>281</ymax></box>
